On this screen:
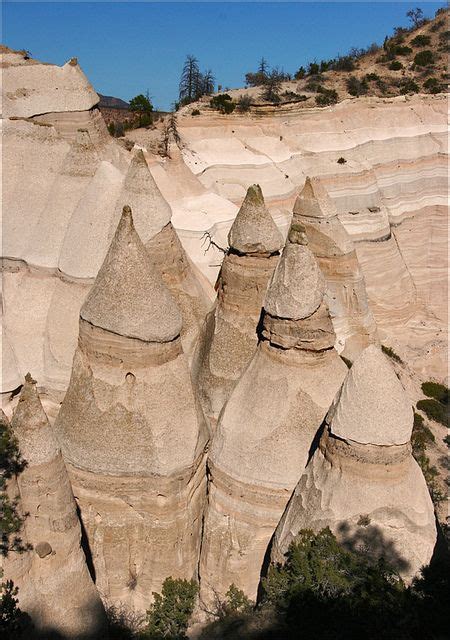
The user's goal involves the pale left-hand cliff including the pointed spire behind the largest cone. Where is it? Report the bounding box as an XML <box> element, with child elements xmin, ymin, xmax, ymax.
<box><xmin>1</xmin><ymin>52</ymin><xmax>213</xmax><ymax>410</ymax></box>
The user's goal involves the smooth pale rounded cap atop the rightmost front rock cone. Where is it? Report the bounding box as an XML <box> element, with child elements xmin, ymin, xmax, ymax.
<box><xmin>331</xmin><ymin>345</ymin><xmax>413</xmax><ymax>446</ymax></box>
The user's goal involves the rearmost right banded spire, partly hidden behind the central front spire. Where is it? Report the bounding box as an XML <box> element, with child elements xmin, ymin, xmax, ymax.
<box><xmin>293</xmin><ymin>178</ymin><xmax>377</xmax><ymax>361</ymax></box>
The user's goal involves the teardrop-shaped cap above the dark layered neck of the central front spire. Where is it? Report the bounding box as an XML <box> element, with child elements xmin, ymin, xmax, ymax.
<box><xmin>264</xmin><ymin>235</ymin><xmax>325</xmax><ymax>320</ymax></box>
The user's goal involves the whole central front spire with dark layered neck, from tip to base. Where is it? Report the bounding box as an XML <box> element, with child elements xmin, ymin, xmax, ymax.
<box><xmin>200</xmin><ymin>229</ymin><xmax>347</xmax><ymax>603</ymax></box>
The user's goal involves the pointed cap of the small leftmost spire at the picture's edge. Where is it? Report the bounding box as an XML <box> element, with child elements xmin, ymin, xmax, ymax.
<box><xmin>11</xmin><ymin>373</ymin><xmax>60</xmax><ymax>466</ymax></box>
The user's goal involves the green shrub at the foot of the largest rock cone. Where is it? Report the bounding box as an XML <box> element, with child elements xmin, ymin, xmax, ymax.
<box><xmin>142</xmin><ymin>578</ymin><xmax>198</xmax><ymax>640</ymax></box>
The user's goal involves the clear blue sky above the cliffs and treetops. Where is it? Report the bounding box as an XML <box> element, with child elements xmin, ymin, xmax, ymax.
<box><xmin>2</xmin><ymin>0</ymin><xmax>444</xmax><ymax>109</ymax></box>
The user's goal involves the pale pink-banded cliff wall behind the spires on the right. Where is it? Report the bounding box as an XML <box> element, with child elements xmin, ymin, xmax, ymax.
<box><xmin>168</xmin><ymin>95</ymin><xmax>448</xmax><ymax>380</ymax></box>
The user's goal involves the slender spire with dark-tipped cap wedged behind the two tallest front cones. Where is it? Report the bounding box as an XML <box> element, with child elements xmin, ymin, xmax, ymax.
<box><xmin>193</xmin><ymin>185</ymin><xmax>283</xmax><ymax>426</ymax></box>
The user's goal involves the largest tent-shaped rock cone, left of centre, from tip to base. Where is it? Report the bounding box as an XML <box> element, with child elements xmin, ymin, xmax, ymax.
<box><xmin>55</xmin><ymin>207</ymin><xmax>208</xmax><ymax>611</ymax></box>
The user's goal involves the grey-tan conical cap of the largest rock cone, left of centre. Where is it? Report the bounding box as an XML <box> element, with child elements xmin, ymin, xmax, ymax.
<box><xmin>80</xmin><ymin>206</ymin><xmax>182</xmax><ymax>342</ymax></box>
